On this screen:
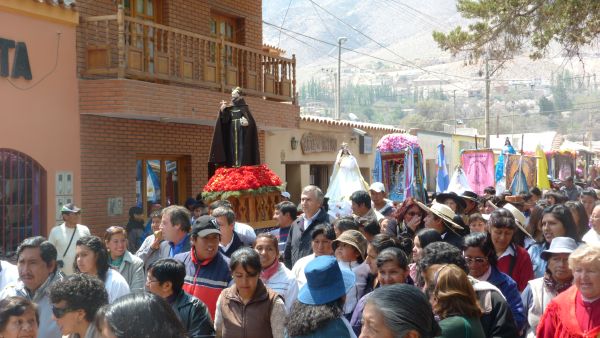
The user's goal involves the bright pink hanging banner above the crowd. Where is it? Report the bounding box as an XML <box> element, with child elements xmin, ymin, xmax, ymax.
<box><xmin>461</xmin><ymin>149</ymin><xmax>495</xmax><ymax>195</ymax></box>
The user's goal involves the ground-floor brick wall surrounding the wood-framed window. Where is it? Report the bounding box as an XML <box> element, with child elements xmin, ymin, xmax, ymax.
<box><xmin>81</xmin><ymin>115</ymin><xmax>265</xmax><ymax>234</ymax></box>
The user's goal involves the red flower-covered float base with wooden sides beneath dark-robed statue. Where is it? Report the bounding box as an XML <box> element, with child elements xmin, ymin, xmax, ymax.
<box><xmin>202</xmin><ymin>164</ymin><xmax>285</xmax><ymax>229</ymax></box>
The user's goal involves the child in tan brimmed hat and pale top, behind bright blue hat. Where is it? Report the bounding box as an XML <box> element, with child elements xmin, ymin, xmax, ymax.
<box><xmin>332</xmin><ymin>230</ymin><xmax>370</xmax><ymax>320</ymax></box>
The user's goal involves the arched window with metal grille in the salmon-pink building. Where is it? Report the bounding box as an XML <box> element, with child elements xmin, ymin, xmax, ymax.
<box><xmin>0</xmin><ymin>148</ymin><xmax>46</xmax><ymax>257</ymax></box>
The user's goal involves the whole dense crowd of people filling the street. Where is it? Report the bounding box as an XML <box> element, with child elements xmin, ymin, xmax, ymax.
<box><xmin>0</xmin><ymin>173</ymin><xmax>600</xmax><ymax>338</ymax></box>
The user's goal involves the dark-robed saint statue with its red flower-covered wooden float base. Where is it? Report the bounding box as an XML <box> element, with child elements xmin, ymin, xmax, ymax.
<box><xmin>202</xmin><ymin>87</ymin><xmax>284</xmax><ymax>229</ymax></box>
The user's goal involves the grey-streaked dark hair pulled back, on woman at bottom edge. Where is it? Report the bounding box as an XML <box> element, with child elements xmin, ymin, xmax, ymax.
<box><xmin>367</xmin><ymin>284</ymin><xmax>441</xmax><ymax>338</ymax></box>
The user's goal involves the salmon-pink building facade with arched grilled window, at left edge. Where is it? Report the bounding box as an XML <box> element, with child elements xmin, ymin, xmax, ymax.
<box><xmin>0</xmin><ymin>0</ymin><xmax>82</xmax><ymax>256</ymax></box>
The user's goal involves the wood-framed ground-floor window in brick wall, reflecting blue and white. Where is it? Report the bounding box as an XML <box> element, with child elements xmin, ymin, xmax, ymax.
<box><xmin>136</xmin><ymin>156</ymin><xmax>186</xmax><ymax>214</ymax></box>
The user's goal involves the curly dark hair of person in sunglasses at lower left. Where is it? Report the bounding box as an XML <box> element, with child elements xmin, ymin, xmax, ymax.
<box><xmin>50</xmin><ymin>273</ymin><xmax>108</xmax><ymax>323</ymax></box>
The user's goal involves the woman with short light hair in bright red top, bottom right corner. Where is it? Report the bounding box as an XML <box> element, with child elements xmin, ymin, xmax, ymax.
<box><xmin>537</xmin><ymin>244</ymin><xmax>600</xmax><ymax>338</ymax></box>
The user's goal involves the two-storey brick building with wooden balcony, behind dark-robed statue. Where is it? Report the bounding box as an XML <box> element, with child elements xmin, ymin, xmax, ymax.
<box><xmin>77</xmin><ymin>0</ymin><xmax>299</xmax><ymax>233</ymax></box>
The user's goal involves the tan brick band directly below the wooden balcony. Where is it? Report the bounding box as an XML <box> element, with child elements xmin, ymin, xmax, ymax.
<box><xmin>79</xmin><ymin>79</ymin><xmax>299</xmax><ymax>129</ymax></box>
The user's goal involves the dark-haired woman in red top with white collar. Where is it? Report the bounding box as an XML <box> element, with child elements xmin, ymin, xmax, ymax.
<box><xmin>488</xmin><ymin>208</ymin><xmax>533</xmax><ymax>292</ymax></box>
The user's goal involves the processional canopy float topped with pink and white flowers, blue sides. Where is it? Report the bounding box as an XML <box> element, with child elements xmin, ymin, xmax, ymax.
<box><xmin>373</xmin><ymin>133</ymin><xmax>427</xmax><ymax>202</ymax></box>
